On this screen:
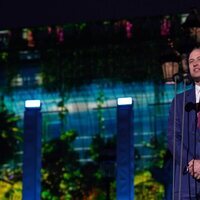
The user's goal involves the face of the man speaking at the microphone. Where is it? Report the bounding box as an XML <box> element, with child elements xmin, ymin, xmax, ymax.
<box><xmin>188</xmin><ymin>49</ymin><xmax>200</xmax><ymax>82</ymax></box>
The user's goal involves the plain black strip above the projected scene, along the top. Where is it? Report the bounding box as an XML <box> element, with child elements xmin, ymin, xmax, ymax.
<box><xmin>0</xmin><ymin>0</ymin><xmax>200</xmax><ymax>29</ymax></box>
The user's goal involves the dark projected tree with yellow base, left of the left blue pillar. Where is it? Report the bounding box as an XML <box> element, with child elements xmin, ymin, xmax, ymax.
<box><xmin>0</xmin><ymin>97</ymin><xmax>22</xmax><ymax>199</ymax></box>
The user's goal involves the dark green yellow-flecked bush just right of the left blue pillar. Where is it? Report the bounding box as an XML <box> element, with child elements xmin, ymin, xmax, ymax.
<box><xmin>42</xmin><ymin>131</ymin><xmax>81</xmax><ymax>199</ymax></box>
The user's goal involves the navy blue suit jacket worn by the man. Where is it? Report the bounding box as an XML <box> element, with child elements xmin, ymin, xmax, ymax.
<box><xmin>168</xmin><ymin>87</ymin><xmax>200</xmax><ymax>200</ymax></box>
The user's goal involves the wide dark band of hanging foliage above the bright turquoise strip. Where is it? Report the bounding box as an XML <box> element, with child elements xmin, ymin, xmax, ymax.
<box><xmin>41</xmin><ymin>41</ymin><xmax>162</xmax><ymax>92</ymax></box>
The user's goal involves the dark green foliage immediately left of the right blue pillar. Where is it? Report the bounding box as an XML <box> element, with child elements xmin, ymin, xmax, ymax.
<box><xmin>83</xmin><ymin>134</ymin><xmax>116</xmax><ymax>198</ymax></box>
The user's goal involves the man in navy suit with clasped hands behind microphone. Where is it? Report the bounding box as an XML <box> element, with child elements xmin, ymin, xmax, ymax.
<box><xmin>168</xmin><ymin>48</ymin><xmax>200</xmax><ymax>200</ymax></box>
